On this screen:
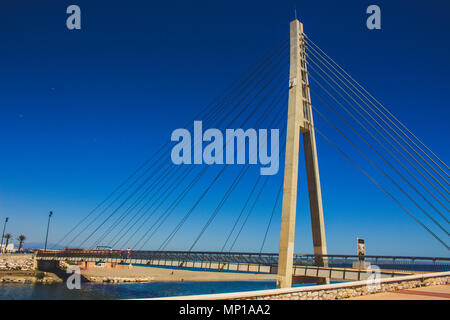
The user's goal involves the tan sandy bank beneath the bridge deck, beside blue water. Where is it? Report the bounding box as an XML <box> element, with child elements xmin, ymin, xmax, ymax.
<box><xmin>81</xmin><ymin>266</ymin><xmax>276</xmax><ymax>283</ymax></box>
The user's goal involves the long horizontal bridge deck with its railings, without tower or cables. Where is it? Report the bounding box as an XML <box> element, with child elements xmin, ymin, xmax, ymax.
<box><xmin>36</xmin><ymin>249</ymin><xmax>450</xmax><ymax>282</ymax></box>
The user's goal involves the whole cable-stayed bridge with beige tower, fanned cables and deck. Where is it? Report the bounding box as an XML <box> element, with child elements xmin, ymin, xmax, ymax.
<box><xmin>38</xmin><ymin>20</ymin><xmax>449</xmax><ymax>287</ymax></box>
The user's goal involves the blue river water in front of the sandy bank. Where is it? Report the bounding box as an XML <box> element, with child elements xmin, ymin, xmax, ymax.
<box><xmin>0</xmin><ymin>281</ymin><xmax>282</xmax><ymax>300</ymax></box>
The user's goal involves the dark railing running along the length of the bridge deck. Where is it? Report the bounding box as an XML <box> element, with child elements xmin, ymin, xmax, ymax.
<box><xmin>36</xmin><ymin>249</ymin><xmax>450</xmax><ymax>272</ymax></box>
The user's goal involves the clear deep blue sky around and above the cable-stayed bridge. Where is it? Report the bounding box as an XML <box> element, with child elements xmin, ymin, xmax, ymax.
<box><xmin>0</xmin><ymin>0</ymin><xmax>450</xmax><ymax>256</ymax></box>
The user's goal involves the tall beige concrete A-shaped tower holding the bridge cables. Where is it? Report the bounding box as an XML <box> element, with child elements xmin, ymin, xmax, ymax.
<box><xmin>277</xmin><ymin>19</ymin><xmax>328</xmax><ymax>288</ymax></box>
